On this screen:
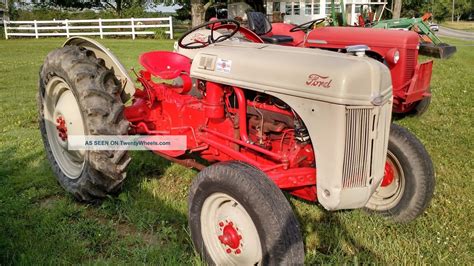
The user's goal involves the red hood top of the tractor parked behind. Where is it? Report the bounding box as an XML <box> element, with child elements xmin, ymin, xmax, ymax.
<box><xmin>305</xmin><ymin>27</ymin><xmax>419</xmax><ymax>49</ymax></box>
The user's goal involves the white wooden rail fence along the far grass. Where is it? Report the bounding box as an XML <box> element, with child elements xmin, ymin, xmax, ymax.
<box><xmin>4</xmin><ymin>17</ymin><xmax>173</xmax><ymax>39</ymax></box>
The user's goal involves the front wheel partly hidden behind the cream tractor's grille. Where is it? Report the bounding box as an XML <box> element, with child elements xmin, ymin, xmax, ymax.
<box><xmin>366</xmin><ymin>124</ymin><xmax>435</xmax><ymax>223</ymax></box>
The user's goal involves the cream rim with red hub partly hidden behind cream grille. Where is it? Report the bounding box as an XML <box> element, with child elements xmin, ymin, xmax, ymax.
<box><xmin>367</xmin><ymin>151</ymin><xmax>405</xmax><ymax>211</ymax></box>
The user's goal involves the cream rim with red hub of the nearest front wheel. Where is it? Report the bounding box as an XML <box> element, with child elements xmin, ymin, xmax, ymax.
<box><xmin>201</xmin><ymin>193</ymin><xmax>262</xmax><ymax>265</ymax></box>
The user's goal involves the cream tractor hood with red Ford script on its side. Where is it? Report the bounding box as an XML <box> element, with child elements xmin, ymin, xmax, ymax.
<box><xmin>191</xmin><ymin>41</ymin><xmax>392</xmax><ymax>105</ymax></box>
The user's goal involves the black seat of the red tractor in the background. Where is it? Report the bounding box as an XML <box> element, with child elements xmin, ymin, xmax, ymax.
<box><xmin>247</xmin><ymin>12</ymin><xmax>293</xmax><ymax>44</ymax></box>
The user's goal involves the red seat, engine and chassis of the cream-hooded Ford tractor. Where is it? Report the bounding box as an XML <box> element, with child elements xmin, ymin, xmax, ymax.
<box><xmin>124</xmin><ymin>53</ymin><xmax>316</xmax><ymax>202</ymax></box>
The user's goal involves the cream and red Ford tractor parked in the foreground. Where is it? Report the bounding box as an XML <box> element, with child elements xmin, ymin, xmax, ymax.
<box><xmin>37</xmin><ymin>20</ymin><xmax>434</xmax><ymax>265</ymax></box>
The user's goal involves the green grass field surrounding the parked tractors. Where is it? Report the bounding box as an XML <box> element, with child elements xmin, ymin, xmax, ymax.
<box><xmin>0</xmin><ymin>39</ymin><xmax>474</xmax><ymax>265</ymax></box>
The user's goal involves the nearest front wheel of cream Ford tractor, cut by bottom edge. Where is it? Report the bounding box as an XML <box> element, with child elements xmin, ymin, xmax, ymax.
<box><xmin>189</xmin><ymin>162</ymin><xmax>304</xmax><ymax>265</ymax></box>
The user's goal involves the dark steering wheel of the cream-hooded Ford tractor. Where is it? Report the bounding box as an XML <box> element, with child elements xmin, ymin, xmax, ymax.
<box><xmin>178</xmin><ymin>19</ymin><xmax>240</xmax><ymax>49</ymax></box>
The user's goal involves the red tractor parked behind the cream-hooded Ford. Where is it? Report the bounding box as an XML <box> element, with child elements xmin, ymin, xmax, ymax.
<box><xmin>216</xmin><ymin>12</ymin><xmax>433</xmax><ymax>118</ymax></box>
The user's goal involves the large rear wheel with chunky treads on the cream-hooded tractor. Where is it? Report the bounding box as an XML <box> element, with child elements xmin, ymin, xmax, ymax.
<box><xmin>37</xmin><ymin>46</ymin><xmax>130</xmax><ymax>202</ymax></box>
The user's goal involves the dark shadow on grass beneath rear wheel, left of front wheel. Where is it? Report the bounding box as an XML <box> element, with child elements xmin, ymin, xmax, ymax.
<box><xmin>0</xmin><ymin>145</ymin><xmax>195</xmax><ymax>265</ymax></box>
